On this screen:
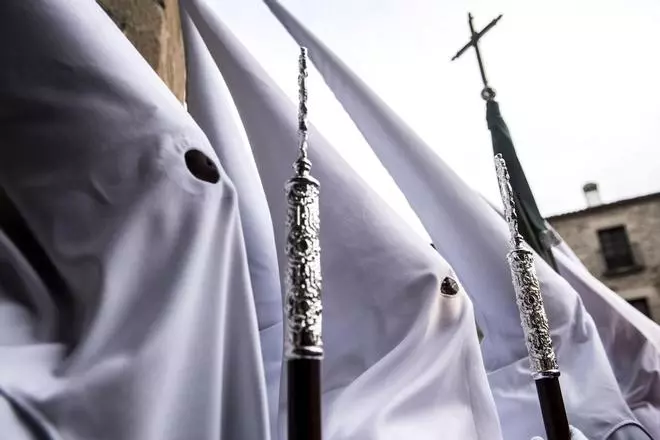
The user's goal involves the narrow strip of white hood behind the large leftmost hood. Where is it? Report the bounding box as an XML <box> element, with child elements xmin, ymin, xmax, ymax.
<box><xmin>181</xmin><ymin>13</ymin><xmax>284</xmax><ymax>440</ymax></box>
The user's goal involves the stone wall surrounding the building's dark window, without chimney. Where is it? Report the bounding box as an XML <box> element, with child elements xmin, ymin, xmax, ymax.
<box><xmin>548</xmin><ymin>194</ymin><xmax>660</xmax><ymax>322</ymax></box>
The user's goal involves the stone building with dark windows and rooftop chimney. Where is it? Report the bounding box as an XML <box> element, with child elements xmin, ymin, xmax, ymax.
<box><xmin>548</xmin><ymin>184</ymin><xmax>660</xmax><ymax>323</ymax></box>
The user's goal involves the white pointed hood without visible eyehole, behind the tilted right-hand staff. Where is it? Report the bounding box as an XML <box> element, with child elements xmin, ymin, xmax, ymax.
<box><xmin>266</xmin><ymin>1</ymin><xmax>648</xmax><ymax>439</ymax></box>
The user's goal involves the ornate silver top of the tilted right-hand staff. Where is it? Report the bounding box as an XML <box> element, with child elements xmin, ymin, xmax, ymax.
<box><xmin>495</xmin><ymin>154</ymin><xmax>559</xmax><ymax>379</ymax></box>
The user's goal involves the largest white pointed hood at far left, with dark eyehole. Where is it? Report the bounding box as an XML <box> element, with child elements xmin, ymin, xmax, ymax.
<box><xmin>0</xmin><ymin>0</ymin><xmax>269</xmax><ymax>440</ymax></box>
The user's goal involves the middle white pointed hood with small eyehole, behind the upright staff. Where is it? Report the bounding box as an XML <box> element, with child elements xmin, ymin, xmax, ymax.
<box><xmin>182</xmin><ymin>0</ymin><xmax>501</xmax><ymax>440</ymax></box>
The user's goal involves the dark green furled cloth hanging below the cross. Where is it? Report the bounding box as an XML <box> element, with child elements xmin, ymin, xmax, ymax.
<box><xmin>486</xmin><ymin>101</ymin><xmax>557</xmax><ymax>270</ymax></box>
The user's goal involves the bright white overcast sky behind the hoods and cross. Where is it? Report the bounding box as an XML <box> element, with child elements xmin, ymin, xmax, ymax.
<box><xmin>210</xmin><ymin>0</ymin><xmax>660</xmax><ymax>232</ymax></box>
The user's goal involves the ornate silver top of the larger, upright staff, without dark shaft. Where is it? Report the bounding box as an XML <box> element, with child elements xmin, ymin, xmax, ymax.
<box><xmin>284</xmin><ymin>47</ymin><xmax>323</xmax><ymax>359</ymax></box>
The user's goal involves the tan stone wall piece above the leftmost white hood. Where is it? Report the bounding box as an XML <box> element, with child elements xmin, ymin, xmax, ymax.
<box><xmin>97</xmin><ymin>0</ymin><xmax>185</xmax><ymax>101</ymax></box>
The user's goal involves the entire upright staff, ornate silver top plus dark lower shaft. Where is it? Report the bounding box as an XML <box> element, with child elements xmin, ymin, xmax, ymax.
<box><xmin>284</xmin><ymin>47</ymin><xmax>323</xmax><ymax>440</ymax></box>
